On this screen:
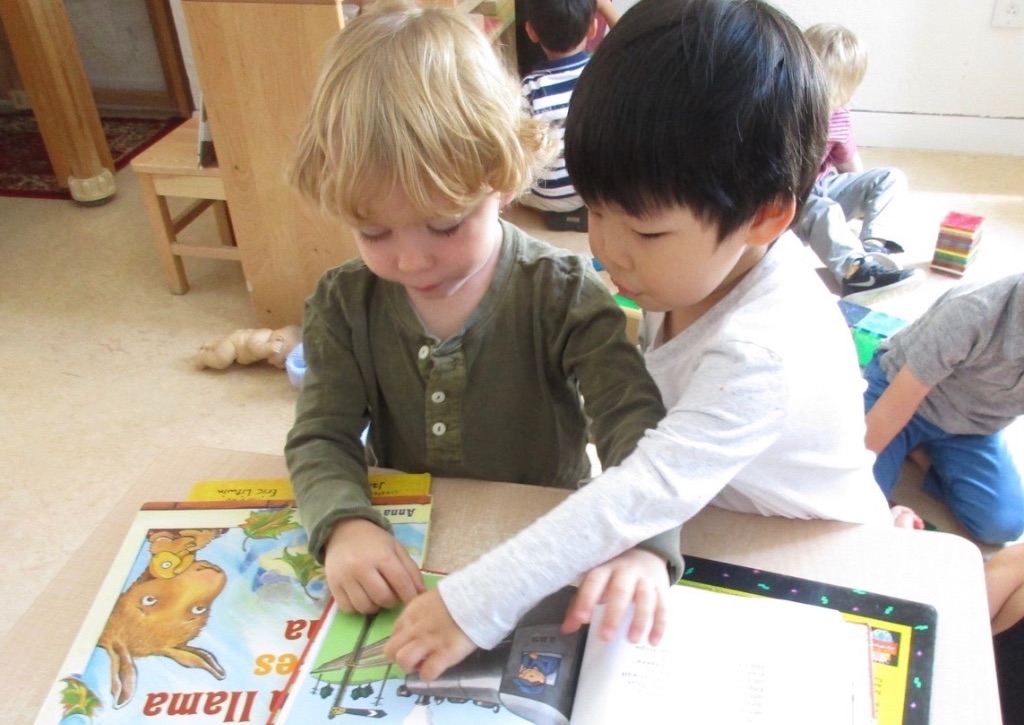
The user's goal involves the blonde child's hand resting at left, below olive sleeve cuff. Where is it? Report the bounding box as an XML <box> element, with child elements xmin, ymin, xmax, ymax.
<box><xmin>324</xmin><ymin>518</ymin><xmax>426</xmax><ymax>614</ymax></box>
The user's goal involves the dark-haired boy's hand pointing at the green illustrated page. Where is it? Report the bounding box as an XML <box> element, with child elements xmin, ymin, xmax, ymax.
<box><xmin>384</xmin><ymin>589</ymin><xmax>476</xmax><ymax>682</ymax></box>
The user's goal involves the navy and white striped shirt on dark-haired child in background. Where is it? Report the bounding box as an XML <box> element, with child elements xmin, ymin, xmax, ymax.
<box><xmin>522</xmin><ymin>51</ymin><xmax>590</xmax><ymax>212</ymax></box>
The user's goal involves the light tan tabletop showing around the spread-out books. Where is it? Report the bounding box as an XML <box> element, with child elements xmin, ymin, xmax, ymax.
<box><xmin>0</xmin><ymin>447</ymin><xmax>1000</xmax><ymax>725</ymax></box>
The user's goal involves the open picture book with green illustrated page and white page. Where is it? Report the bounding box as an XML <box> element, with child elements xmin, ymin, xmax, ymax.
<box><xmin>272</xmin><ymin>577</ymin><xmax>873</xmax><ymax>725</ymax></box>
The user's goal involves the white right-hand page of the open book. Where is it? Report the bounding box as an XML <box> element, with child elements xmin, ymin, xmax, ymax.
<box><xmin>571</xmin><ymin>586</ymin><xmax>867</xmax><ymax>725</ymax></box>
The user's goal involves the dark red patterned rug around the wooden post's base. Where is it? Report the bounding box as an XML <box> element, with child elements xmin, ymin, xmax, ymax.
<box><xmin>0</xmin><ymin>111</ymin><xmax>182</xmax><ymax>200</ymax></box>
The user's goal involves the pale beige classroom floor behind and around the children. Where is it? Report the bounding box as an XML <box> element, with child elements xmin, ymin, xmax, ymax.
<box><xmin>0</xmin><ymin>150</ymin><xmax>1024</xmax><ymax>647</ymax></box>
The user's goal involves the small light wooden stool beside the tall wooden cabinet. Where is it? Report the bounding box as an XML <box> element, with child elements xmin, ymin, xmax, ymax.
<box><xmin>131</xmin><ymin>118</ymin><xmax>242</xmax><ymax>295</ymax></box>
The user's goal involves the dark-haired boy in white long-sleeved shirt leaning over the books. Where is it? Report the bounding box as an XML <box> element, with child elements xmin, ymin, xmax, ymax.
<box><xmin>387</xmin><ymin>0</ymin><xmax>892</xmax><ymax>680</ymax></box>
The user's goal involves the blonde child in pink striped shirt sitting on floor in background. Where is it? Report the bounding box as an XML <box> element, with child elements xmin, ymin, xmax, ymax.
<box><xmin>794</xmin><ymin>23</ymin><xmax>924</xmax><ymax>305</ymax></box>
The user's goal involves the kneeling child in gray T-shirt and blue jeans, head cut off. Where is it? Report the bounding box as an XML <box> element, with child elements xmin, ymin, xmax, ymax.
<box><xmin>864</xmin><ymin>274</ymin><xmax>1024</xmax><ymax>544</ymax></box>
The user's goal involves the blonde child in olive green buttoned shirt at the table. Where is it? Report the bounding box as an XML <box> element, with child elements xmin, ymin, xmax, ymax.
<box><xmin>285</xmin><ymin>3</ymin><xmax>681</xmax><ymax>612</ymax></box>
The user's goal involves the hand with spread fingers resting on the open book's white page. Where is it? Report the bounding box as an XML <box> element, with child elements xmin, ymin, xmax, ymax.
<box><xmin>562</xmin><ymin>549</ymin><xmax>670</xmax><ymax>645</ymax></box>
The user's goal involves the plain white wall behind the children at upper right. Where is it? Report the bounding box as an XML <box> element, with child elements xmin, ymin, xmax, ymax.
<box><xmin>614</xmin><ymin>0</ymin><xmax>1024</xmax><ymax>156</ymax></box>
